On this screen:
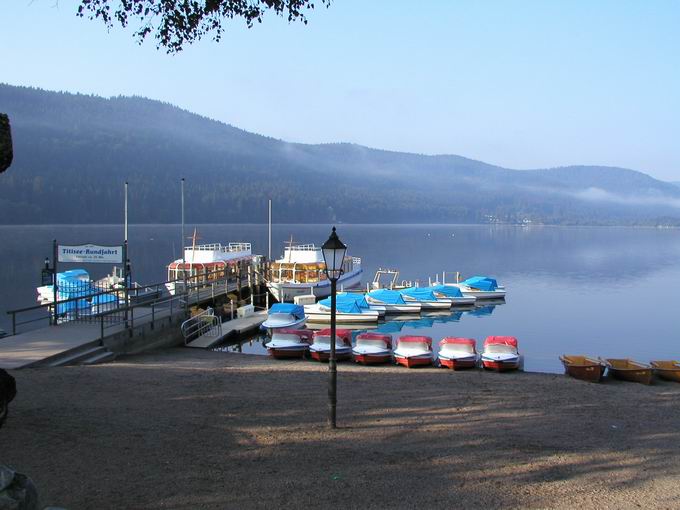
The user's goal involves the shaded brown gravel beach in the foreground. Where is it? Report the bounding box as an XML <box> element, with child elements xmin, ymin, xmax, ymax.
<box><xmin>0</xmin><ymin>348</ymin><xmax>680</xmax><ymax>509</ymax></box>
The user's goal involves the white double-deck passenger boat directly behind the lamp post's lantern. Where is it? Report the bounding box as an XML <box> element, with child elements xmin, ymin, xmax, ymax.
<box><xmin>267</xmin><ymin>243</ymin><xmax>362</xmax><ymax>303</ymax></box>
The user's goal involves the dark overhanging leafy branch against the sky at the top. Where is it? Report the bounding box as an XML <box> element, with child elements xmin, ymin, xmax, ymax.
<box><xmin>78</xmin><ymin>0</ymin><xmax>330</xmax><ymax>53</ymax></box>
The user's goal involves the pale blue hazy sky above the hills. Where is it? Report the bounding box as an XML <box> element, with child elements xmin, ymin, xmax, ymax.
<box><xmin>0</xmin><ymin>0</ymin><xmax>680</xmax><ymax>180</ymax></box>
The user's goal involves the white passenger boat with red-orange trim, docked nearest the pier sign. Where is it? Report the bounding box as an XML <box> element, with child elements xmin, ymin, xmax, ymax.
<box><xmin>165</xmin><ymin>241</ymin><xmax>258</xmax><ymax>296</ymax></box>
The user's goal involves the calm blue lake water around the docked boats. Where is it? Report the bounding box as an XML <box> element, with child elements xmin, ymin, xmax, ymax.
<box><xmin>0</xmin><ymin>225</ymin><xmax>680</xmax><ymax>372</ymax></box>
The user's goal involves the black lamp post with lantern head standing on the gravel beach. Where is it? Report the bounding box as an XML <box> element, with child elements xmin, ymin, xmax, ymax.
<box><xmin>321</xmin><ymin>227</ymin><xmax>347</xmax><ymax>429</ymax></box>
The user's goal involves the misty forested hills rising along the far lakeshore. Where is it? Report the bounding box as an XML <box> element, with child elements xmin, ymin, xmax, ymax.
<box><xmin>0</xmin><ymin>85</ymin><xmax>680</xmax><ymax>225</ymax></box>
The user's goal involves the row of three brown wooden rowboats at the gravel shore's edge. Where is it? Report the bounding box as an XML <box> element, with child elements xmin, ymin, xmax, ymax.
<box><xmin>560</xmin><ymin>355</ymin><xmax>680</xmax><ymax>384</ymax></box>
